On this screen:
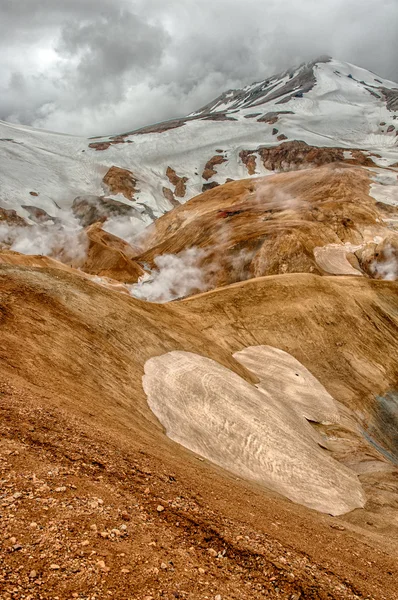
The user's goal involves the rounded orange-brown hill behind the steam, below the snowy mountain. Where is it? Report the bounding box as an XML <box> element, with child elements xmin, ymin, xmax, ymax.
<box><xmin>135</xmin><ymin>163</ymin><xmax>396</xmax><ymax>288</ymax></box>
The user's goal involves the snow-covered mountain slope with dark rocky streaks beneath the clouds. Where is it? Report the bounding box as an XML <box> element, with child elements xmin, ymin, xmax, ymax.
<box><xmin>0</xmin><ymin>57</ymin><xmax>398</xmax><ymax>229</ymax></box>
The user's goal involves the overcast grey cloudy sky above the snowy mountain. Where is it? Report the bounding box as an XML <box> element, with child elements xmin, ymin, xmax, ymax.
<box><xmin>0</xmin><ymin>0</ymin><xmax>398</xmax><ymax>135</ymax></box>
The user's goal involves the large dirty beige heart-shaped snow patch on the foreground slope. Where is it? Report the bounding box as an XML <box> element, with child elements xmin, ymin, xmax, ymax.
<box><xmin>143</xmin><ymin>346</ymin><xmax>365</xmax><ymax>515</ymax></box>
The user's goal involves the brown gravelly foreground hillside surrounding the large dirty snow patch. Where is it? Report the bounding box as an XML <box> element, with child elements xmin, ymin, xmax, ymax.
<box><xmin>0</xmin><ymin>256</ymin><xmax>398</xmax><ymax>600</ymax></box>
